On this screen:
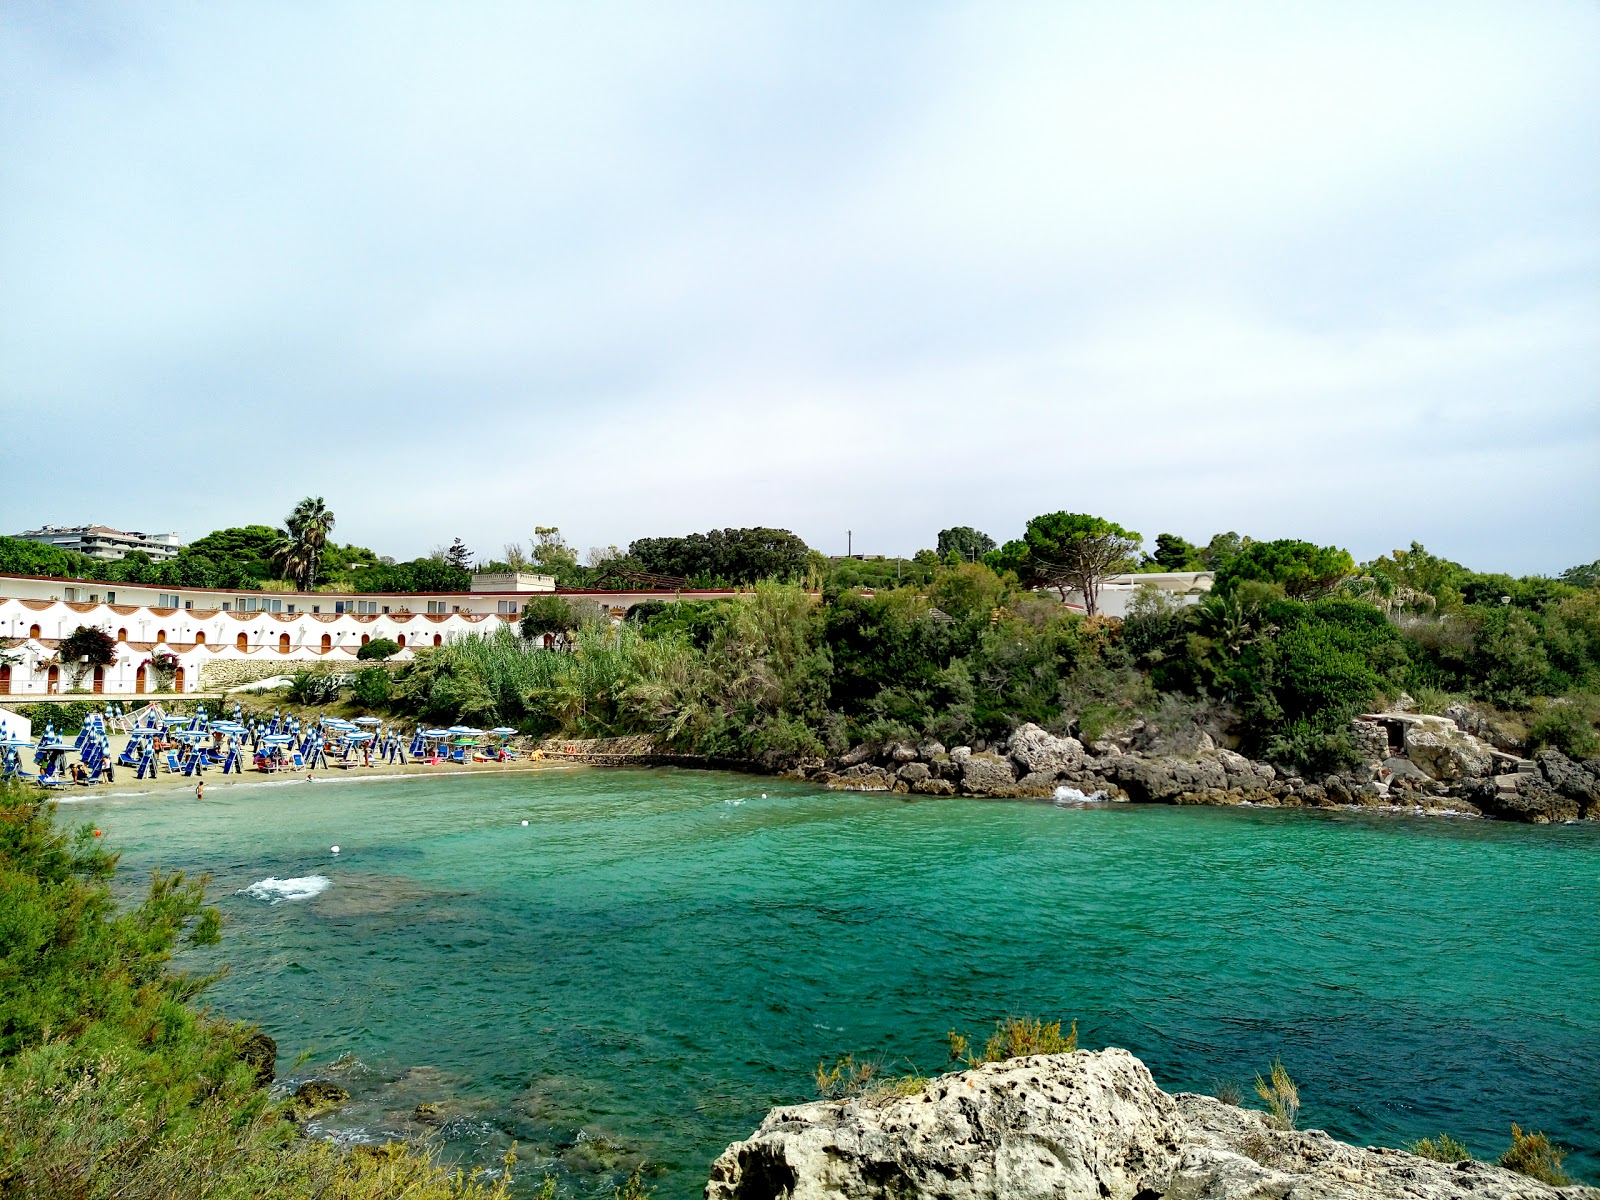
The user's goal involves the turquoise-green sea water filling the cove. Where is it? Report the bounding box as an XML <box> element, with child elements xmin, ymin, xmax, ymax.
<box><xmin>64</xmin><ymin>770</ymin><xmax>1600</xmax><ymax>1198</ymax></box>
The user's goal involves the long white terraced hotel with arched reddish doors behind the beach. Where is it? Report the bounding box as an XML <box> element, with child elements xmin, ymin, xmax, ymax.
<box><xmin>0</xmin><ymin>574</ymin><xmax>736</xmax><ymax>698</ymax></box>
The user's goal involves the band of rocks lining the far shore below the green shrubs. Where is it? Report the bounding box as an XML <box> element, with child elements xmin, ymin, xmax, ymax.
<box><xmin>782</xmin><ymin>706</ymin><xmax>1600</xmax><ymax>824</ymax></box>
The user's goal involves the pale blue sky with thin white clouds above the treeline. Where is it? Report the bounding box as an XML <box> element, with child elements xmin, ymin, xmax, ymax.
<box><xmin>0</xmin><ymin>0</ymin><xmax>1600</xmax><ymax>573</ymax></box>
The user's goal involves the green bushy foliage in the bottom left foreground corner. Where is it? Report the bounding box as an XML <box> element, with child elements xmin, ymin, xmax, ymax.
<box><xmin>0</xmin><ymin>795</ymin><xmax>506</xmax><ymax>1200</ymax></box>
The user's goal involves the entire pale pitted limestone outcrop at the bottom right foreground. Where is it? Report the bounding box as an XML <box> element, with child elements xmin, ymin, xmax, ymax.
<box><xmin>706</xmin><ymin>1050</ymin><xmax>1600</xmax><ymax>1200</ymax></box>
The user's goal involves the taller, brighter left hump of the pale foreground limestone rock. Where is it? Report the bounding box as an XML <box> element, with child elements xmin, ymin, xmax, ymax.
<box><xmin>706</xmin><ymin>1050</ymin><xmax>1182</xmax><ymax>1200</ymax></box>
